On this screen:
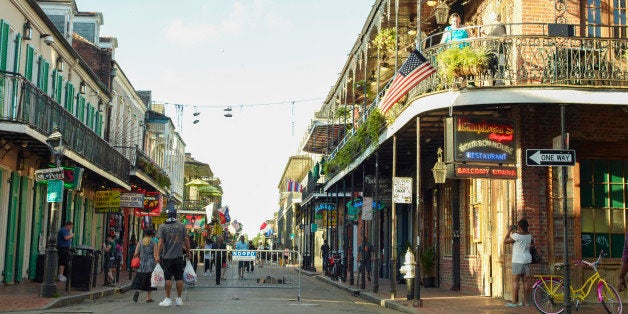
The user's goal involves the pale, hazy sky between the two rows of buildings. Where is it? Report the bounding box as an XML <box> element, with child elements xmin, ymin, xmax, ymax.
<box><xmin>76</xmin><ymin>0</ymin><xmax>374</xmax><ymax>237</ymax></box>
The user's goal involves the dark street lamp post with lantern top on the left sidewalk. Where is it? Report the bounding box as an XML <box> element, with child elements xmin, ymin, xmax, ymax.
<box><xmin>41</xmin><ymin>128</ymin><xmax>65</xmax><ymax>298</ymax></box>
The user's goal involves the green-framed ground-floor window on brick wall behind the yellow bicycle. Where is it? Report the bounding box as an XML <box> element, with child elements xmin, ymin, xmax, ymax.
<box><xmin>580</xmin><ymin>160</ymin><xmax>628</xmax><ymax>258</ymax></box>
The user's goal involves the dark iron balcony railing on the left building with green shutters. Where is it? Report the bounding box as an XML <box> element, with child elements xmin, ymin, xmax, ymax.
<box><xmin>0</xmin><ymin>72</ymin><xmax>129</xmax><ymax>182</ymax></box>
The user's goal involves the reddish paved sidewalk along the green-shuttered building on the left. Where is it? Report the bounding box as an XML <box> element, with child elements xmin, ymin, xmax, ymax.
<box><xmin>0</xmin><ymin>270</ymin><xmax>132</xmax><ymax>312</ymax></box>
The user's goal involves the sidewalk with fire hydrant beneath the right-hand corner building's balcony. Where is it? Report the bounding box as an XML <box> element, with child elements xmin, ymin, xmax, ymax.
<box><xmin>303</xmin><ymin>270</ymin><xmax>536</xmax><ymax>313</ymax></box>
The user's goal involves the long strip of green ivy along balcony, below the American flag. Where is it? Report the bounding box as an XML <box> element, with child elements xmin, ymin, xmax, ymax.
<box><xmin>323</xmin><ymin>110</ymin><xmax>386</xmax><ymax>174</ymax></box>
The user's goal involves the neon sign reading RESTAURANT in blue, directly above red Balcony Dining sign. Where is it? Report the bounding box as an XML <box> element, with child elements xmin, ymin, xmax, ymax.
<box><xmin>445</xmin><ymin>116</ymin><xmax>517</xmax><ymax>164</ymax></box>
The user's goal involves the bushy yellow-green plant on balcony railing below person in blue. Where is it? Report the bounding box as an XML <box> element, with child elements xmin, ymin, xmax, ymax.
<box><xmin>436</xmin><ymin>46</ymin><xmax>489</xmax><ymax>83</ymax></box>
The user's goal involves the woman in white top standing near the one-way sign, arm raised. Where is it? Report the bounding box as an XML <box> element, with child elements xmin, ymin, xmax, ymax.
<box><xmin>504</xmin><ymin>219</ymin><xmax>534</xmax><ymax>307</ymax></box>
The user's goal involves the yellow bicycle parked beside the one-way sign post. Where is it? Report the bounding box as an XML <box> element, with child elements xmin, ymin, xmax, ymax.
<box><xmin>532</xmin><ymin>252</ymin><xmax>622</xmax><ymax>313</ymax></box>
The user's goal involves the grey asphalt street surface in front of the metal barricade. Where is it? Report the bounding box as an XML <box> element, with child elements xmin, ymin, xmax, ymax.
<box><xmin>22</xmin><ymin>275</ymin><xmax>397</xmax><ymax>314</ymax></box>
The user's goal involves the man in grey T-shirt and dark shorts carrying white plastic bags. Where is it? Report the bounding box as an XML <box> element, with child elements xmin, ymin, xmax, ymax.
<box><xmin>155</xmin><ymin>210</ymin><xmax>190</xmax><ymax>306</ymax></box>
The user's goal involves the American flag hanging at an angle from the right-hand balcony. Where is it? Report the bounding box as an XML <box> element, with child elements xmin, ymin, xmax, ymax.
<box><xmin>379</xmin><ymin>50</ymin><xmax>436</xmax><ymax>113</ymax></box>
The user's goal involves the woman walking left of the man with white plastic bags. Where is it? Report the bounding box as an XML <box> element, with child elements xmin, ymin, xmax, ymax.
<box><xmin>131</xmin><ymin>228</ymin><xmax>157</xmax><ymax>303</ymax></box>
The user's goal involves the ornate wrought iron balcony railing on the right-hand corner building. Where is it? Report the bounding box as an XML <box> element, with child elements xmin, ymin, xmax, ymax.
<box><xmin>328</xmin><ymin>23</ymin><xmax>628</xmax><ymax>177</ymax></box>
